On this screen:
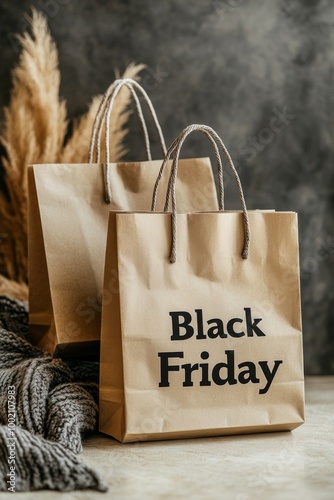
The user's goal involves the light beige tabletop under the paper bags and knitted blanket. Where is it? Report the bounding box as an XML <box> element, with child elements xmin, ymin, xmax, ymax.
<box><xmin>0</xmin><ymin>377</ymin><xmax>334</xmax><ymax>500</ymax></box>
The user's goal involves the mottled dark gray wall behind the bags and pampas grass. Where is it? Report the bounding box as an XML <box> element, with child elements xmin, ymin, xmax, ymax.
<box><xmin>0</xmin><ymin>0</ymin><xmax>334</xmax><ymax>374</ymax></box>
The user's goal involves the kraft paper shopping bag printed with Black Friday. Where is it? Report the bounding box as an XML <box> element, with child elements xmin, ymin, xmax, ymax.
<box><xmin>100</xmin><ymin>125</ymin><xmax>304</xmax><ymax>442</ymax></box>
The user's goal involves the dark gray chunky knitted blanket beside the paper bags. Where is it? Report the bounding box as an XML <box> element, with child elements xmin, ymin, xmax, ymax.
<box><xmin>0</xmin><ymin>296</ymin><xmax>106</xmax><ymax>491</ymax></box>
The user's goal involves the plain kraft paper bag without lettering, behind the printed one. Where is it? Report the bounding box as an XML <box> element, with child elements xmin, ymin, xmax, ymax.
<box><xmin>28</xmin><ymin>79</ymin><xmax>217</xmax><ymax>356</ymax></box>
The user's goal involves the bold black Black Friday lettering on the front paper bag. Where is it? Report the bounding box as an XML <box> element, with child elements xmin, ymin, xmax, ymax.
<box><xmin>158</xmin><ymin>307</ymin><xmax>283</xmax><ymax>394</ymax></box>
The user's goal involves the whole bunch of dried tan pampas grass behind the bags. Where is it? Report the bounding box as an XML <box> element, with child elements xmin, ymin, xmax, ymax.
<box><xmin>0</xmin><ymin>9</ymin><xmax>145</xmax><ymax>300</ymax></box>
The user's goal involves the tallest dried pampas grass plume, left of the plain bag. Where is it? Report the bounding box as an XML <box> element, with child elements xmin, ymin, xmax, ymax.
<box><xmin>0</xmin><ymin>10</ymin><xmax>67</xmax><ymax>283</ymax></box>
